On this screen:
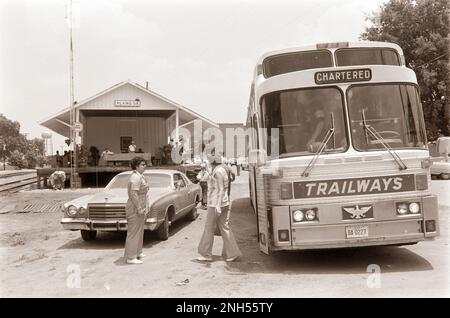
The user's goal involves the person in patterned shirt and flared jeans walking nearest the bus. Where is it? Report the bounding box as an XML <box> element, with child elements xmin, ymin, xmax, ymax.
<box><xmin>197</xmin><ymin>156</ymin><xmax>242</xmax><ymax>262</ymax></box>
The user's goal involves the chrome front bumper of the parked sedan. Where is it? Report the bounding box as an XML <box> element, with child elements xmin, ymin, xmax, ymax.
<box><xmin>61</xmin><ymin>218</ymin><xmax>158</xmax><ymax>231</ymax></box>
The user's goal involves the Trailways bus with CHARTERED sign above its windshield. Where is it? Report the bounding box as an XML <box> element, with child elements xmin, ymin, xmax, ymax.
<box><xmin>247</xmin><ymin>42</ymin><xmax>439</xmax><ymax>253</ymax></box>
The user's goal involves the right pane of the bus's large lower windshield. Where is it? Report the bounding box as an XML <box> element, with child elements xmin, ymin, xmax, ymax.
<box><xmin>347</xmin><ymin>84</ymin><xmax>426</xmax><ymax>151</ymax></box>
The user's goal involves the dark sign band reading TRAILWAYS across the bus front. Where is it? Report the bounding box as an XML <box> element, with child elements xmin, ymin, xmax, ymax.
<box><xmin>294</xmin><ymin>174</ymin><xmax>415</xmax><ymax>198</ymax></box>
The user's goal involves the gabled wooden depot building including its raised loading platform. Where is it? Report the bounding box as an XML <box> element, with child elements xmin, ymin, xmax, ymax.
<box><xmin>37</xmin><ymin>81</ymin><xmax>239</xmax><ymax>187</ymax></box>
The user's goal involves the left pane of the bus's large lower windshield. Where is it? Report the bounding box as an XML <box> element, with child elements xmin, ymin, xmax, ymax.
<box><xmin>261</xmin><ymin>87</ymin><xmax>347</xmax><ymax>158</ymax></box>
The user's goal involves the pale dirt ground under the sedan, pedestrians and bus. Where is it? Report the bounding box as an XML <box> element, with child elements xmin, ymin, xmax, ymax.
<box><xmin>0</xmin><ymin>172</ymin><xmax>450</xmax><ymax>297</ymax></box>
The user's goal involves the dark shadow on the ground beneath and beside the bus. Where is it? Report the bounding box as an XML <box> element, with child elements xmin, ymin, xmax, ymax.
<box><xmin>227</xmin><ymin>198</ymin><xmax>433</xmax><ymax>274</ymax></box>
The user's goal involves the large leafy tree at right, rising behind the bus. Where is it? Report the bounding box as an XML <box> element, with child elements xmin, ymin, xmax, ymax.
<box><xmin>361</xmin><ymin>0</ymin><xmax>450</xmax><ymax>140</ymax></box>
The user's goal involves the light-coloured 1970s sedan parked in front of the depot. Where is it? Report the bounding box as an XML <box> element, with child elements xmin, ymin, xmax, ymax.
<box><xmin>61</xmin><ymin>169</ymin><xmax>202</xmax><ymax>241</ymax></box>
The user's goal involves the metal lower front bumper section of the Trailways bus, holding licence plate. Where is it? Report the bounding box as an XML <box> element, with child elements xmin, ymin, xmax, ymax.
<box><xmin>271</xmin><ymin>196</ymin><xmax>439</xmax><ymax>250</ymax></box>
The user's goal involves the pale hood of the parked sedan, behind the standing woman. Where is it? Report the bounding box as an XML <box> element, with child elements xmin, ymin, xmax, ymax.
<box><xmin>65</xmin><ymin>188</ymin><xmax>174</xmax><ymax>208</ymax></box>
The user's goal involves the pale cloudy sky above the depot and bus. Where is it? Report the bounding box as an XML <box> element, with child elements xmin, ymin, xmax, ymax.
<box><xmin>0</xmin><ymin>0</ymin><xmax>386</xmax><ymax>151</ymax></box>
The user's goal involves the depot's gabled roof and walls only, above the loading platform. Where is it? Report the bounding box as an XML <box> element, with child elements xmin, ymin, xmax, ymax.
<box><xmin>39</xmin><ymin>81</ymin><xmax>219</xmax><ymax>156</ymax></box>
